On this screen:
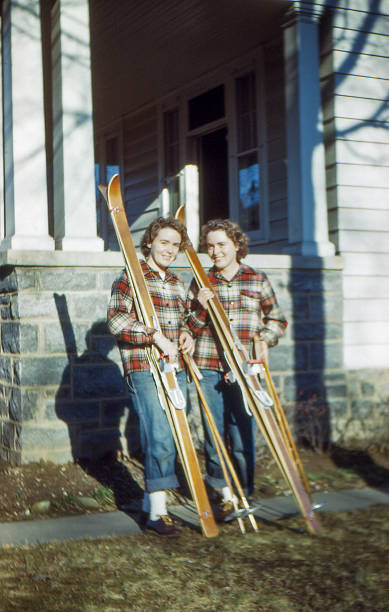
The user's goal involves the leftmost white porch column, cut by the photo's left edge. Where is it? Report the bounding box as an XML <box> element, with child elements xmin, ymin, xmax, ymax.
<box><xmin>0</xmin><ymin>0</ymin><xmax>54</xmax><ymax>250</ymax></box>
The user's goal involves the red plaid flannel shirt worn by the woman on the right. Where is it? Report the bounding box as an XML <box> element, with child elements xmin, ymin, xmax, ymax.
<box><xmin>186</xmin><ymin>264</ymin><xmax>288</xmax><ymax>372</ymax></box>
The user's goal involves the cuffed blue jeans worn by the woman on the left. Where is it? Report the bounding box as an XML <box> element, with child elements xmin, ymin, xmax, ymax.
<box><xmin>127</xmin><ymin>370</ymin><xmax>186</xmax><ymax>493</ymax></box>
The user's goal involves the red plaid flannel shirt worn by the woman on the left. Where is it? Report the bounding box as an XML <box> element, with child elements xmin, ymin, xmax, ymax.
<box><xmin>107</xmin><ymin>261</ymin><xmax>190</xmax><ymax>374</ymax></box>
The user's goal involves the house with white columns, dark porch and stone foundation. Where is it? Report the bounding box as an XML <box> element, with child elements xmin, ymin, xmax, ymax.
<box><xmin>0</xmin><ymin>0</ymin><xmax>389</xmax><ymax>463</ymax></box>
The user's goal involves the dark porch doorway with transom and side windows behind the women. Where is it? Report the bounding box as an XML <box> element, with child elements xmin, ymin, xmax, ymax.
<box><xmin>159</xmin><ymin>58</ymin><xmax>267</xmax><ymax>244</ymax></box>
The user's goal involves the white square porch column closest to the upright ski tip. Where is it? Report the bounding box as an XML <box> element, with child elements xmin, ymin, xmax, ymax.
<box><xmin>52</xmin><ymin>0</ymin><xmax>104</xmax><ymax>251</ymax></box>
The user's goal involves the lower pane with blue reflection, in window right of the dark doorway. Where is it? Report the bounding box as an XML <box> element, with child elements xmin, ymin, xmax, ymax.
<box><xmin>238</xmin><ymin>153</ymin><xmax>260</xmax><ymax>232</ymax></box>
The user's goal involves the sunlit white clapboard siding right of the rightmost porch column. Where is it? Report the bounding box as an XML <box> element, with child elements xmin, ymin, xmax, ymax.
<box><xmin>321</xmin><ymin>5</ymin><xmax>389</xmax><ymax>369</ymax></box>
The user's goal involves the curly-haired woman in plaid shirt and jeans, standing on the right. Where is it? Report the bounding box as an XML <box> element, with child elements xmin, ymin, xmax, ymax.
<box><xmin>186</xmin><ymin>219</ymin><xmax>287</xmax><ymax>520</ymax></box>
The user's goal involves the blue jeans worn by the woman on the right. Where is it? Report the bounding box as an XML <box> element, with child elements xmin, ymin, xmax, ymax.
<box><xmin>200</xmin><ymin>370</ymin><xmax>255</xmax><ymax>495</ymax></box>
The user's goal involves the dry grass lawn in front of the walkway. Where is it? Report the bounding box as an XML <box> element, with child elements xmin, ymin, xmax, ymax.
<box><xmin>0</xmin><ymin>507</ymin><xmax>389</xmax><ymax>612</ymax></box>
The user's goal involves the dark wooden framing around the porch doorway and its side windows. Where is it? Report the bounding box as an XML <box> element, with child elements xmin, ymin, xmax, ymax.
<box><xmin>158</xmin><ymin>48</ymin><xmax>269</xmax><ymax>246</ymax></box>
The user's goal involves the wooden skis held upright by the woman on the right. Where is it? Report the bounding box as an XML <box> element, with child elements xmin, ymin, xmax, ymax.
<box><xmin>176</xmin><ymin>206</ymin><xmax>322</xmax><ymax>534</ymax></box>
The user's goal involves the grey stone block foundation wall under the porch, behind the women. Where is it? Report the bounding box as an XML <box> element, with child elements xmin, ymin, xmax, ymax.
<box><xmin>0</xmin><ymin>253</ymin><xmax>389</xmax><ymax>464</ymax></box>
